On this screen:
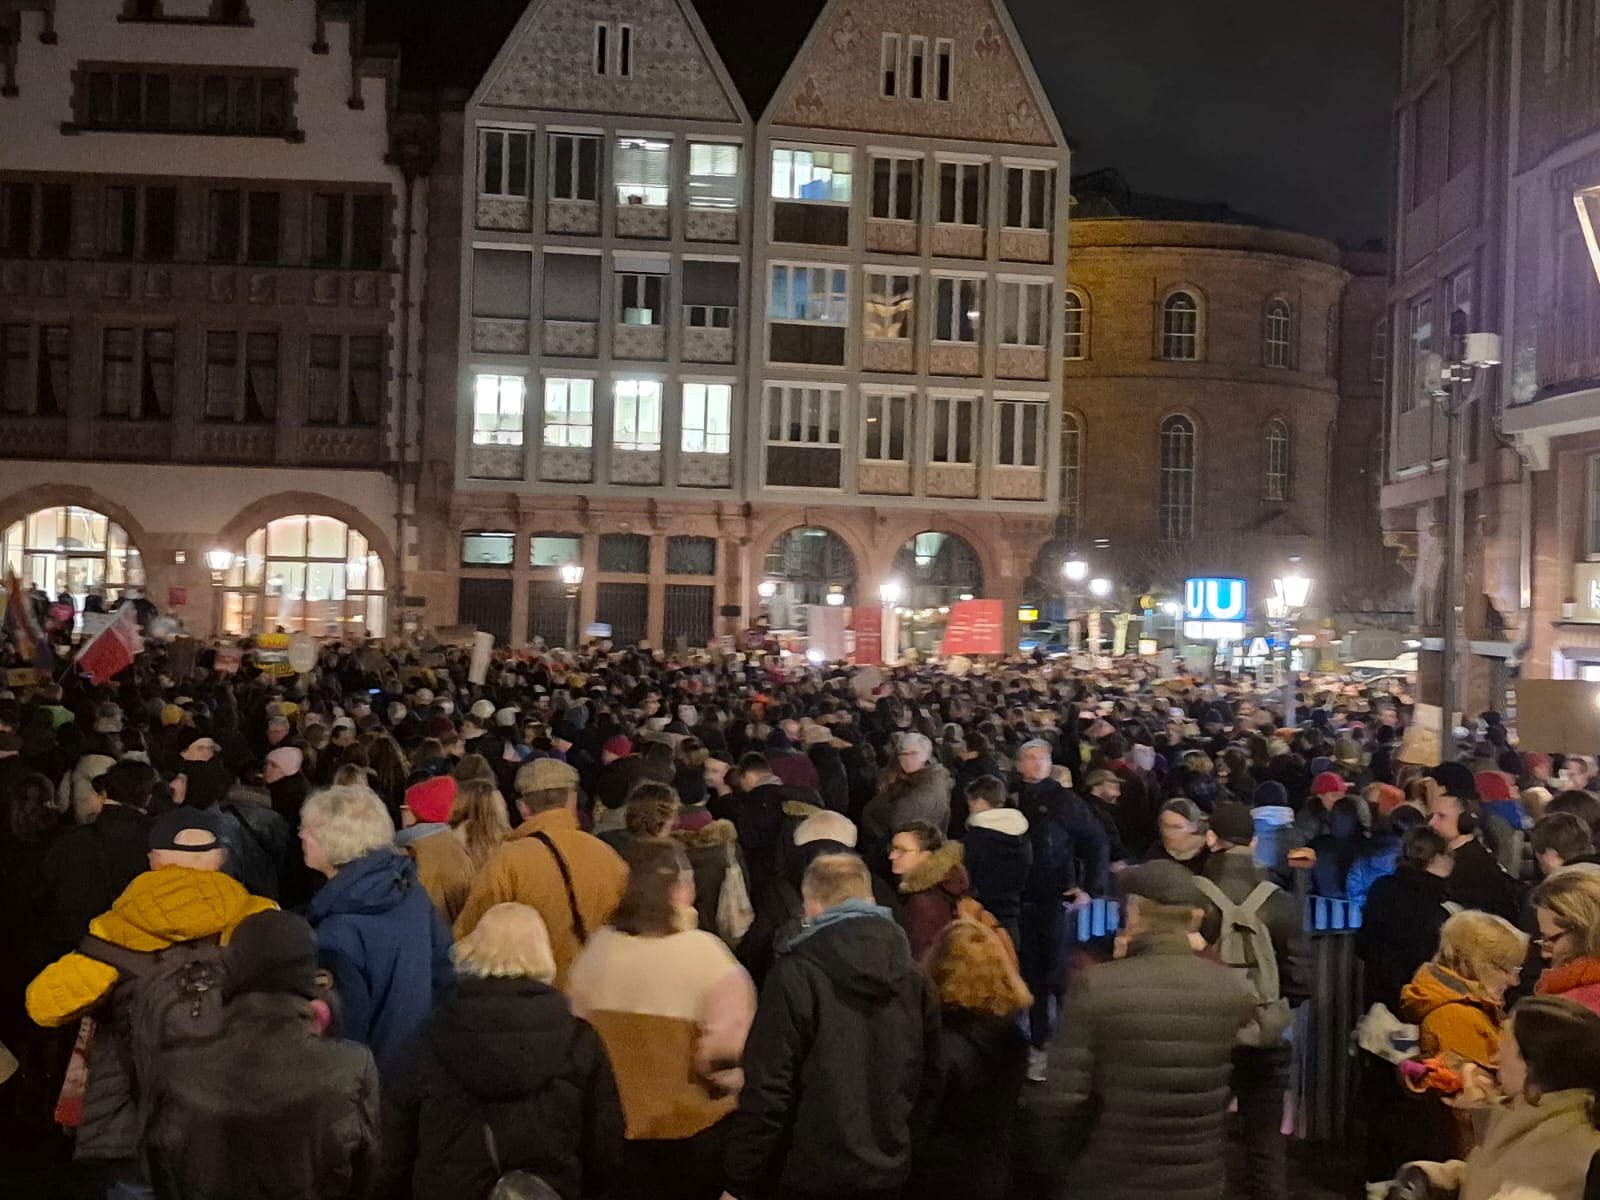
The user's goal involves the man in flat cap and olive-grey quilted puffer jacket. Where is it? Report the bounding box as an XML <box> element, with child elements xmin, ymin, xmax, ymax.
<box><xmin>1038</xmin><ymin>861</ymin><xmax>1254</xmax><ymax>1200</ymax></box>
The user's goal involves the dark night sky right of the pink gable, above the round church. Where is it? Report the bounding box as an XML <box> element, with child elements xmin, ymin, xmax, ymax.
<box><xmin>1010</xmin><ymin>0</ymin><xmax>1400</xmax><ymax>243</ymax></box>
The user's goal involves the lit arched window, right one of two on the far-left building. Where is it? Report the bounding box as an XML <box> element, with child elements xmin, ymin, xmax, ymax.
<box><xmin>222</xmin><ymin>515</ymin><xmax>387</xmax><ymax>637</ymax></box>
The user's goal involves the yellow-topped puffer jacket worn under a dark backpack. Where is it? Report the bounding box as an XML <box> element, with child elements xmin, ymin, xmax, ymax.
<box><xmin>26</xmin><ymin>867</ymin><xmax>277</xmax><ymax>1162</ymax></box>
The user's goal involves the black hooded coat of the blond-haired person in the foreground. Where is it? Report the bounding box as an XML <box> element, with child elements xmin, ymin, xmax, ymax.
<box><xmin>376</xmin><ymin>976</ymin><xmax>622</xmax><ymax>1200</ymax></box>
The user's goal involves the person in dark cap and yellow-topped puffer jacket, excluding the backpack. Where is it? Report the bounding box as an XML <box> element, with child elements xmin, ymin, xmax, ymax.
<box><xmin>26</xmin><ymin>808</ymin><xmax>277</xmax><ymax>1197</ymax></box>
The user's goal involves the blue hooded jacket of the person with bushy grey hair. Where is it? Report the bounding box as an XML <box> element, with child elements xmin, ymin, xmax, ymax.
<box><xmin>306</xmin><ymin>846</ymin><xmax>454</xmax><ymax>1075</ymax></box>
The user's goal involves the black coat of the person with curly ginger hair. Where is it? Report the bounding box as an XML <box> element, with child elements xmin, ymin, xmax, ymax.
<box><xmin>906</xmin><ymin>1008</ymin><xmax>1027</xmax><ymax>1200</ymax></box>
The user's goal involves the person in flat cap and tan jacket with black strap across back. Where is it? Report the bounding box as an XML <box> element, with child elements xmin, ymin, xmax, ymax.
<box><xmin>456</xmin><ymin>758</ymin><xmax>627</xmax><ymax>990</ymax></box>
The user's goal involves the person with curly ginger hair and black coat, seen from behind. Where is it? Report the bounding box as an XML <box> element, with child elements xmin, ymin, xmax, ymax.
<box><xmin>907</xmin><ymin>917</ymin><xmax>1034</xmax><ymax>1200</ymax></box>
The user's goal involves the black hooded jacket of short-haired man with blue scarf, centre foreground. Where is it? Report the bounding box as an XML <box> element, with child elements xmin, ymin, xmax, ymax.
<box><xmin>725</xmin><ymin>901</ymin><xmax>939</xmax><ymax>1200</ymax></box>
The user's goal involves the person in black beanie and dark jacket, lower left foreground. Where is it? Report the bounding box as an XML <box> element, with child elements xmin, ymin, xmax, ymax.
<box><xmin>141</xmin><ymin>910</ymin><xmax>378</xmax><ymax>1200</ymax></box>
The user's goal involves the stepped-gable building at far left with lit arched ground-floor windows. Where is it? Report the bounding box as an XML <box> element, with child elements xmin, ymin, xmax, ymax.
<box><xmin>0</xmin><ymin>0</ymin><xmax>421</xmax><ymax>634</ymax></box>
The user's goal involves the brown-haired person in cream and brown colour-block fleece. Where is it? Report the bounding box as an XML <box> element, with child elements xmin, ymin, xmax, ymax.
<box><xmin>568</xmin><ymin>842</ymin><xmax>755</xmax><ymax>1200</ymax></box>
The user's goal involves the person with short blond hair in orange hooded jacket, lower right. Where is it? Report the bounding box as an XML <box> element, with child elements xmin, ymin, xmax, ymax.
<box><xmin>1400</xmin><ymin>909</ymin><xmax>1528</xmax><ymax>1158</ymax></box>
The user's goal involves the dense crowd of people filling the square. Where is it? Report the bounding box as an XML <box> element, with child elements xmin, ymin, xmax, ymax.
<box><xmin>0</xmin><ymin>633</ymin><xmax>1600</xmax><ymax>1200</ymax></box>
